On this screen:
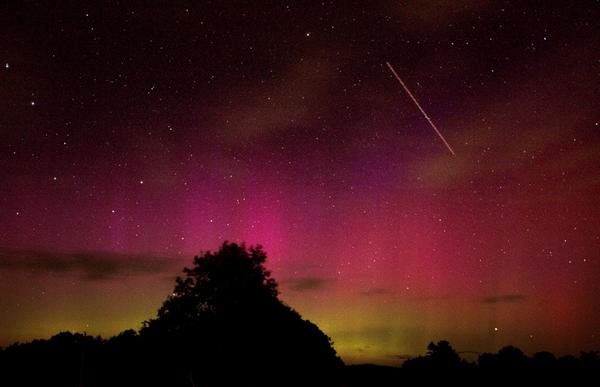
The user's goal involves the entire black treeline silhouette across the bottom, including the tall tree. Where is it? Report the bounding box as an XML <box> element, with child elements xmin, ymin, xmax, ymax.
<box><xmin>0</xmin><ymin>243</ymin><xmax>600</xmax><ymax>387</ymax></box>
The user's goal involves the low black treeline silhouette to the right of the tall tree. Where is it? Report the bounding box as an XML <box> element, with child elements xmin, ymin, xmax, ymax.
<box><xmin>346</xmin><ymin>341</ymin><xmax>600</xmax><ymax>386</ymax></box>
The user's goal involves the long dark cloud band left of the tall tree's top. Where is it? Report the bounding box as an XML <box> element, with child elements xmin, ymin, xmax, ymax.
<box><xmin>0</xmin><ymin>249</ymin><xmax>181</xmax><ymax>281</ymax></box>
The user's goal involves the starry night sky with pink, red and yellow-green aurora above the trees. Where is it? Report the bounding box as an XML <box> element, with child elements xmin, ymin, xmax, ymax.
<box><xmin>0</xmin><ymin>0</ymin><xmax>600</xmax><ymax>364</ymax></box>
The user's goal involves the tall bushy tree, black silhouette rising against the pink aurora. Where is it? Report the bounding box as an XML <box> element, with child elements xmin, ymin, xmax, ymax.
<box><xmin>140</xmin><ymin>242</ymin><xmax>343</xmax><ymax>384</ymax></box>
